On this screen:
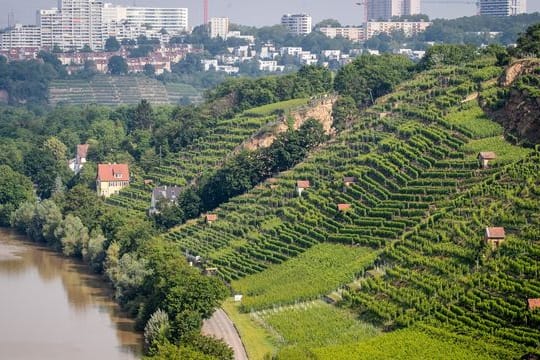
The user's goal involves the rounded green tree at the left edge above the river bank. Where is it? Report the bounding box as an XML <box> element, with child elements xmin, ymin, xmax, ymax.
<box><xmin>0</xmin><ymin>165</ymin><xmax>34</xmax><ymax>226</ymax></box>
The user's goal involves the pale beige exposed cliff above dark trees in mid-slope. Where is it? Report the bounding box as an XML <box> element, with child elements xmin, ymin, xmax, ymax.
<box><xmin>241</xmin><ymin>96</ymin><xmax>337</xmax><ymax>150</ymax></box>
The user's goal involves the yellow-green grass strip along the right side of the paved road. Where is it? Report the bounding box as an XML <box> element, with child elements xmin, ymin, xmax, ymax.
<box><xmin>222</xmin><ymin>299</ymin><xmax>277</xmax><ymax>360</ymax></box>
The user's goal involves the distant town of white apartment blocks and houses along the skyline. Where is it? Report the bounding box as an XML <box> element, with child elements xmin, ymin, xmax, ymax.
<box><xmin>0</xmin><ymin>0</ymin><xmax>526</xmax><ymax>75</ymax></box>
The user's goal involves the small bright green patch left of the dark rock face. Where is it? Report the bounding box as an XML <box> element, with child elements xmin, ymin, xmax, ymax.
<box><xmin>446</xmin><ymin>104</ymin><xmax>503</xmax><ymax>139</ymax></box>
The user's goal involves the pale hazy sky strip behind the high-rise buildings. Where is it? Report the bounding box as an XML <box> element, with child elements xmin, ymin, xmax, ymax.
<box><xmin>0</xmin><ymin>0</ymin><xmax>540</xmax><ymax>26</ymax></box>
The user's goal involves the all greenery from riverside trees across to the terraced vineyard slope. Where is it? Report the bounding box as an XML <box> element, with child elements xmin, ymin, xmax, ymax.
<box><xmin>0</xmin><ymin>23</ymin><xmax>540</xmax><ymax>359</ymax></box>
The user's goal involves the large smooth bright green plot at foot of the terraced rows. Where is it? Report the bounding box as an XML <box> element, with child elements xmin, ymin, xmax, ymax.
<box><xmin>231</xmin><ymin>244</ymin><xmax>378</xmax><ymax>311</ymax></box>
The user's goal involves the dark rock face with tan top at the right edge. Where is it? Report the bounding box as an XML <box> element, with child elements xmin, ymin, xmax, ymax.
<box><xmin>485</xmin><ymin>59</ymin><xmax>540</xmax><ymax>146</ymax></box>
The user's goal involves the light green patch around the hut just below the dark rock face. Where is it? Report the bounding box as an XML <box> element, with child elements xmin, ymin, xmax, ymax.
<box><xmin>463</xmin><ymin>136</ymin><xmax>532</xmax><ymax>163</ymax></box>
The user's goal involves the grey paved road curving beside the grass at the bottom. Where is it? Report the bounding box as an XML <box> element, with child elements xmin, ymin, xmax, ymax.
<box><xmin>202</xmin><ymin>309</ymin><xmax>248</xmax><ymax>360</ymax></box>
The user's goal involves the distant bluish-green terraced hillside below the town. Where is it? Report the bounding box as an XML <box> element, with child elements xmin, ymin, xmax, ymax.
<box><xmin>49</xmin><ymin>75</ymin><xmax>201</xmax><ymax>106</ymax></box>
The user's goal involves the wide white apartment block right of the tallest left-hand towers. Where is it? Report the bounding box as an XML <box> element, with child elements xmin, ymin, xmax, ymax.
<box><xmin>126</xmin><ymin>7</ymin><xmax>188</xmax><ymax>35</ymax></box>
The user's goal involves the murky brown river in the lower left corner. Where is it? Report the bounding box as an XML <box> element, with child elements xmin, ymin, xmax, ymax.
<box><xmin>0</xmin><ymin>228</ymin><xmax>142</xmax><ymax>360</ymax></box>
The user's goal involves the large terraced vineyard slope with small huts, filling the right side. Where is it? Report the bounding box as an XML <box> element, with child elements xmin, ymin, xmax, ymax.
<box><xmin>157</xmin><ymin>55</ymin><xmax>540</xmax><ymax>359</ymax></box>
